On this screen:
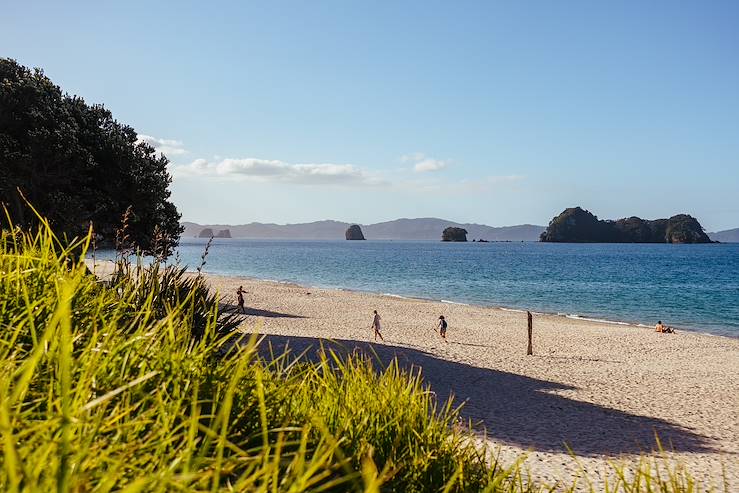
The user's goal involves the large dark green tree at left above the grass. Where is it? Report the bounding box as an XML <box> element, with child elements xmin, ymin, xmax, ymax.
<box><xmin>0</xmin><ymin>58</ymin><xmax>182</xmax><ymax>253</ymax></box>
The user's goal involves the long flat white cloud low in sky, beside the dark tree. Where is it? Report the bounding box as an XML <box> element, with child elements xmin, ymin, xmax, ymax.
<box><xmin>172</xmin><ymin>158</ymin><xmax>385</xmax><ymax>186</ymax></box>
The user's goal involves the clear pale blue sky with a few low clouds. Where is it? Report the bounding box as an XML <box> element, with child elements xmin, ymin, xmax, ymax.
<box><xmin>0</xmin><ymin>0</ymin><xmax>739</xmax><ymax>231</ymax></box>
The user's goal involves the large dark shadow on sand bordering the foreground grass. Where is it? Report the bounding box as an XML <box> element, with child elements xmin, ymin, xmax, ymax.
<box><xmin>236</xmin><ymin>335</ymin><xmax>715</xmax><ymax>456</ymax></box>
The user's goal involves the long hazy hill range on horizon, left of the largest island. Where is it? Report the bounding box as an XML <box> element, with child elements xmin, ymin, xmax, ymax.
<box><xmin>182</xmin><ymin>218</ymin><xmax>546</xmax><ymax>241</ymax></box>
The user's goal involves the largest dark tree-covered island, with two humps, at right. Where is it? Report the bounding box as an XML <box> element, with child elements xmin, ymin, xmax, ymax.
<box><xmin>539</xmin><ymin>207</ymin><xmax>712</xmax><ymax>243</ymax></box>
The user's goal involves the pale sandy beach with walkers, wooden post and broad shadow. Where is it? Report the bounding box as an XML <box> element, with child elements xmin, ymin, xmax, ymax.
<box><xmin>207</xmin><ymin>275</ymin><xmax>739</xmax><ymax>491</ymax></box>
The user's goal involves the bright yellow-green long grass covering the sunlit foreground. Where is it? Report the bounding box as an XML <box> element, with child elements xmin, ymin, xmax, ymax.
<box><xmin>0</xmin><ymin>221</ymin><xmax>720</xmax><ymax>492</ymax></box>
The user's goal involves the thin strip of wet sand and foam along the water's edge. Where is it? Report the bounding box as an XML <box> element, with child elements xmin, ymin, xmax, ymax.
<box><xmin>198</xmin><ymin>269</ymin><xmax>739</xmax><ymax>340</ymax></box>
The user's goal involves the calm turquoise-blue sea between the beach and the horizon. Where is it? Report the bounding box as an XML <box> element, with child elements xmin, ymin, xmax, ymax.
<box><xmin>99</xmin><ymin>239</ymin><xmax>739</xmax><ymax>337</ymax></box>
